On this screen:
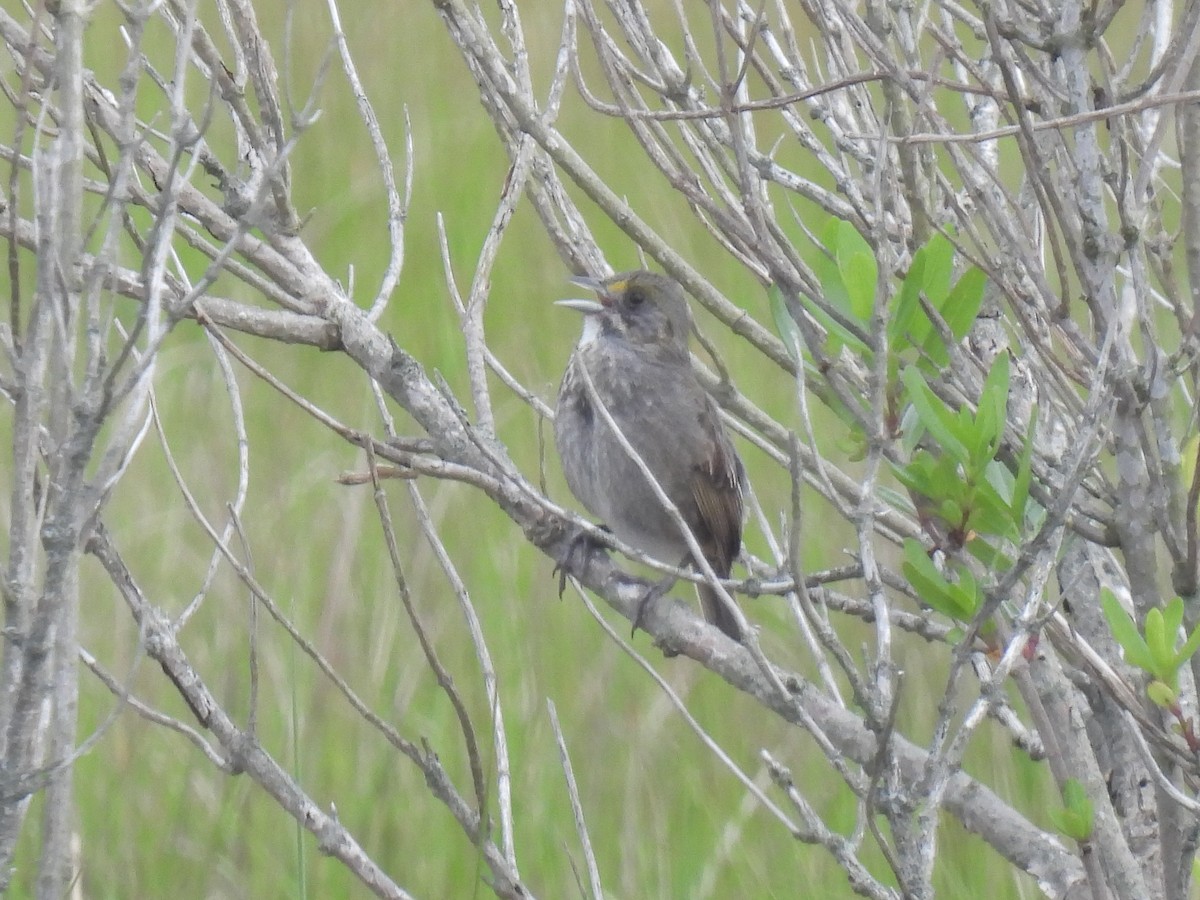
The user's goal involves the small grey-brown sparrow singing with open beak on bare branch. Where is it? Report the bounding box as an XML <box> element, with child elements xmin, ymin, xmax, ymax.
<box><xmin>554</xmin><ymin>270</ymin><xmax>745</xmax><ymax>642</ymax></box>
